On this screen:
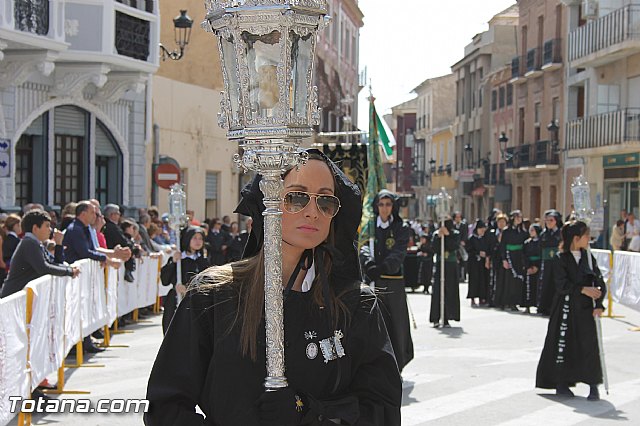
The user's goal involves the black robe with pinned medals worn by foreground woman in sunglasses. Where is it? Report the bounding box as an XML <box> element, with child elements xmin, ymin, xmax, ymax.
<box><xmin>145</xmin><ymin>284</ymin><xmax>402</xmax><ymax>426</ymax></box>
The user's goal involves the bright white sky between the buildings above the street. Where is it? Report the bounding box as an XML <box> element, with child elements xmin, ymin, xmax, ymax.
<box><xmin>358</xmin><ymin>0</ymin><xmax>516</xmax><ymax>130</ymax></box>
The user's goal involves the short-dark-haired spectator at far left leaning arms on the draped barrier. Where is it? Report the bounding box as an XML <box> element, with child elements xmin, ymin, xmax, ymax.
<box><xmin>0</xmin><ymin>209</ymin><xmax>80</xmax><ymax>297</ymax></box>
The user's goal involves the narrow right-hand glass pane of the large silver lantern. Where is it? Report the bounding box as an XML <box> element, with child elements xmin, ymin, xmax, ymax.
<box><xmin>289</xmin><ymin>31</ymin><xmax>313</xmax><ymax>118</ymax></box>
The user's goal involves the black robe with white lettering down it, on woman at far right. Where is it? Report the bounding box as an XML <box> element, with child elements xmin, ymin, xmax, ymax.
<box><xmin>536</xmin><ymin>250</ymin><xmax>607</xmax><ymax>389</ymax></box>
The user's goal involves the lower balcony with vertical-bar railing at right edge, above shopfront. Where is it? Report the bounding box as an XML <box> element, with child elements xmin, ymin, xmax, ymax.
<box><xmin>566</xmin><ymin>108</ymin><xmax>640</xmax><ymax>150</ymax></box>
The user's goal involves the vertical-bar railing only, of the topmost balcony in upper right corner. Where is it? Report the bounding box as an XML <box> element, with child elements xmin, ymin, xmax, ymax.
<box><xmin>568</xmin><ymin>5</ymin><xmax>640</xmax><ymax>61</ymax></box>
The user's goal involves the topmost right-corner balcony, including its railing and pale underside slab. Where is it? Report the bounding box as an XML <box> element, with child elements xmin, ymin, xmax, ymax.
<box><xmin>568</xmin><ymin>5</ymin><xmax>640</xmax><ymax>68</ymax></box>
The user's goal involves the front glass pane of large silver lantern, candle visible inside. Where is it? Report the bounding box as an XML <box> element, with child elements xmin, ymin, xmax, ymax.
<box><xmin>242</xmin><ymin>31</ymin><xmax>281</xmax><ymax>119</ymax></box>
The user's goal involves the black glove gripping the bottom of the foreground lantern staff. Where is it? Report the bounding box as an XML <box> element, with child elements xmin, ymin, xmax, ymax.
<box><xmin>257</xmin><ymin>388</ymin><xmax>305</xmax><ymax>426</ymax></box>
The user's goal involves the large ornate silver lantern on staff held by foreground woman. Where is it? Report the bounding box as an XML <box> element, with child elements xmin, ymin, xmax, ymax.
<box><xmin>202</xmin><ymin>0</ymin><xmax>330</xmax><ymax>389</ymax></box>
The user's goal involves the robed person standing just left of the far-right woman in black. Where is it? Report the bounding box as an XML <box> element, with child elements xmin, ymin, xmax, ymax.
<box><xmin>537</xmin><ymin>210</ymin><xmax>562</xmax><ymax>316</ymax></box>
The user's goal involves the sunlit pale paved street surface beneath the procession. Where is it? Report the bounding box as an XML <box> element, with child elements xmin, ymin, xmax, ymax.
<box><xmin>11</xmin><ymin>285</ymin><xmax>640</xmax><ymax>426</ymax></box>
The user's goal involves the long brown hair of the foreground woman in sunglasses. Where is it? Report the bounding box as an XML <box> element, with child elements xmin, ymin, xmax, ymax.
<box><xmin>190</xmin><ymin>156</ymin><xmax>350</xmax><ymax>361</ymax></box>
